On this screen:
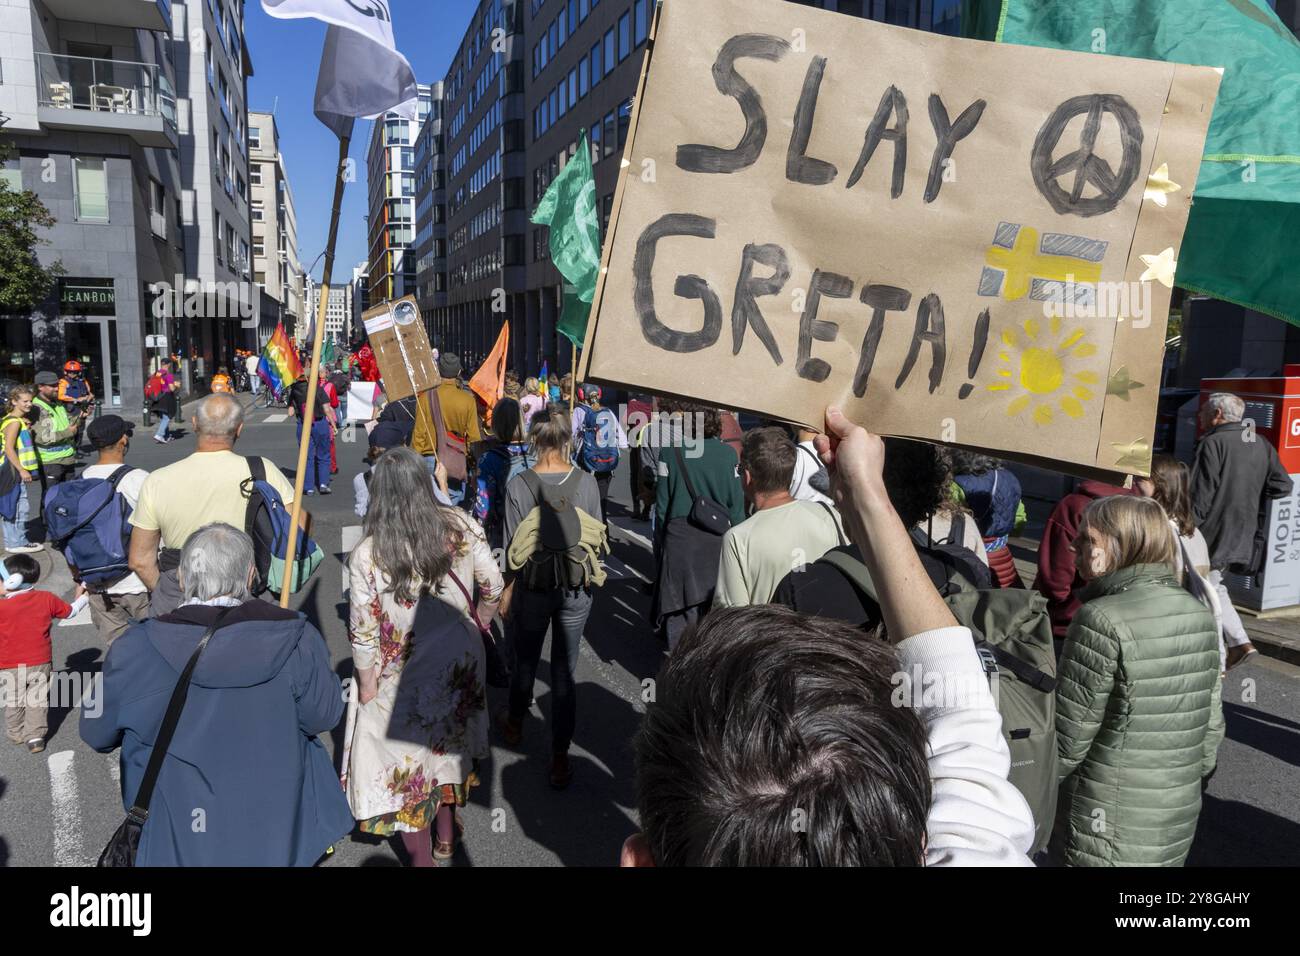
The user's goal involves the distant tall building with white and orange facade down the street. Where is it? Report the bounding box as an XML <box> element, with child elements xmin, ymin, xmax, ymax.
<box><xmin>365</xmin><ymin>85</ymin><xmax>434</xmax><ymax>302</ymax></box>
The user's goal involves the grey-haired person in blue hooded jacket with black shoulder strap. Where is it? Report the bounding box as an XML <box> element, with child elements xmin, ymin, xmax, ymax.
<box><xmin>81</xmin><ymin>524</ymin><xmax>354</xmax><ymax>866</ymax></box>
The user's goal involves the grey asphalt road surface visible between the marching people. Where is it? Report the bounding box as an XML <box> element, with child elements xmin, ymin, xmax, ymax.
<box><xmin>0</xmin><ymin>395</ymin><xmax>1300</xmax><ymax>866</ymax></box>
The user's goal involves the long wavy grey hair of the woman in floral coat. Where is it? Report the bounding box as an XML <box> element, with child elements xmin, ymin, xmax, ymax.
<box><xmin>363</xmin><ymin>447</ymin><xmax>459</xmax><ymax>601</ymax></box>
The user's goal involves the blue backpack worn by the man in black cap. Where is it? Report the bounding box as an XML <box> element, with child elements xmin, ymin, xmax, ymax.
<box><xmin>44</xmin><ymin>464</ymin><xmax>134</xmax><ymax>591</ymax></box>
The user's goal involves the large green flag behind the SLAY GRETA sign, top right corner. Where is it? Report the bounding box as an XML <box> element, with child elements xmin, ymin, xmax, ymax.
<box><xmin>962</xmin><ymin>0</ymin><xmax>1300</xmax><ymax>325</ymax></box>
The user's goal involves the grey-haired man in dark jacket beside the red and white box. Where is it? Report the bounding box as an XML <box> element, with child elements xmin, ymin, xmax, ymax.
<box><xmin>1192</xmin><ymin>392</ymin><xmax>1291</xmax><ymax>667</ymax></box>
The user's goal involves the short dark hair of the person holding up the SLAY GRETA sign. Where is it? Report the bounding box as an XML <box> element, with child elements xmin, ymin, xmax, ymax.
<box><xmin>634</xmin><ymin>605</ymin><xmax>931</xmax><ymax>866</ymax></box>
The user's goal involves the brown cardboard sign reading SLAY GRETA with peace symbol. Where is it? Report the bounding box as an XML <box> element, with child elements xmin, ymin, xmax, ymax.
<box><xmin>581</xmin><ymin>0</ymin><xmax>1219</xmax><ymax>473</ymax></box>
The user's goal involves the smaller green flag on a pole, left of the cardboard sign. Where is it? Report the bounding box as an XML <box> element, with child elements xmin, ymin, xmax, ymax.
<box><xmin>533</xmin><ymin>130</ymin><xmax>601</xmax><ymax>349</ymax></box>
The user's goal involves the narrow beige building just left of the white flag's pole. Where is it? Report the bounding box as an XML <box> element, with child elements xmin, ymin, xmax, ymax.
<box><xmin>248</xmin><ymin>112</ymin><xmax>303</xmax><ymax>347</ymax></box>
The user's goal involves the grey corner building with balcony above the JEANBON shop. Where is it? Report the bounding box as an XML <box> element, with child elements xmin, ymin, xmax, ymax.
<box><xmin>0</xmin><ymin>0</ymin><xmax>185</xmax><ymax>414</ymax></box>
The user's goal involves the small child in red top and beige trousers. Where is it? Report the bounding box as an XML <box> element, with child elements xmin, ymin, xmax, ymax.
<box><xmin>0</xmin><ymin>554</ymin><xmax>86</xmax><ymax>753</ymax></box>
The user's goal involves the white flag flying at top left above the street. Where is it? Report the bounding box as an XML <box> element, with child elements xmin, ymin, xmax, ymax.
<box><xmin>261</xmin><ymin>0</ymin><xmax>417</xmax><ymax>138</ymax></box>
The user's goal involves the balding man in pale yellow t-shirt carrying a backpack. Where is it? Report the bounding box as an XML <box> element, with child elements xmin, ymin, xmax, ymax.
<box><xmin>129</xmin><ymin>393</ymin><xmax>299</xmax><ymax>617</ymax></box>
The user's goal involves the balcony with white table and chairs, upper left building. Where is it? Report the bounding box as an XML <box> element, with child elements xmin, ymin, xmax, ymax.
<box><xmin>36</xmin><ymin>53</ymin><xmax>177</xmax><ymax>150</ymax></box>
